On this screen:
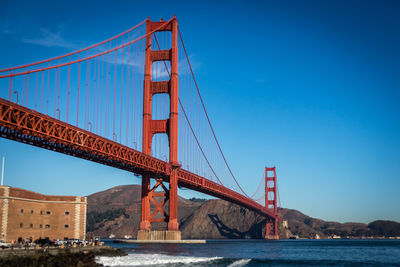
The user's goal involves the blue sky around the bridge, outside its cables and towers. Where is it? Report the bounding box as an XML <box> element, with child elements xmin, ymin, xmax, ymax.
<box><xmin>0</xmin><ymin>0</ymin><xmax>400</xmax><ymax>222</ymax></box>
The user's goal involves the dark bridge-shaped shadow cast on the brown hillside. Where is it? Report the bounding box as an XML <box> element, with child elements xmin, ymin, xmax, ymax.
<box><xmin>208</xmin><ymin>214</ymin><xmax>265</xmax><ymax>239</ymax></box>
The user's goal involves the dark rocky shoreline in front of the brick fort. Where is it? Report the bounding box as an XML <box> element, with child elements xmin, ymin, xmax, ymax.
<box><xmin>0</xmin><ymin>246</ymin><xmax>126</xmax><ymax>267</ymax></box>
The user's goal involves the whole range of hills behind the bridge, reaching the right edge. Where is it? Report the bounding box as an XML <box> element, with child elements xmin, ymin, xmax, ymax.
<box><xmin>87</xmin><ymin>185</ymin><xmax>400</xmax><ymax>239</ymax></box>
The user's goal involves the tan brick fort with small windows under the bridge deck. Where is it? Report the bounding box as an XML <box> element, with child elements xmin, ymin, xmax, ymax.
<box><xmin>0</xmin><ymin>186</ymin><xmax>86</xmax><ymax>242</ymax></box>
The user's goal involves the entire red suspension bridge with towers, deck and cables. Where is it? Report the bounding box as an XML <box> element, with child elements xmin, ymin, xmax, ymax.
<box><xmin>0</xmin><ymin>17</ymin><xmax>278</xmax><ymax>239</ymax></box>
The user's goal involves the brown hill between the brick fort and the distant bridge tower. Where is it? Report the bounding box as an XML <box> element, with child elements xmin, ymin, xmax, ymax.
<box><xmin>87</xmin><ymin>185</ymin><xmax>288</xmax><ymax>239</ymax></box>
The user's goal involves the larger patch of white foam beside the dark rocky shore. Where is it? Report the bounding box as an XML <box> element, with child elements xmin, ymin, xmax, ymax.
<box><xmin>96</xmin><ymin>254</ymin><xmax>223</xmax><ymax>266</ymax></box>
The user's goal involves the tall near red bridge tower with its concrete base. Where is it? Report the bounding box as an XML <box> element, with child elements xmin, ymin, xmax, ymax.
<box><xmin>138</xmin><ymin>17</ymin><xmax>181</xmax><ymax>240</ymax></box>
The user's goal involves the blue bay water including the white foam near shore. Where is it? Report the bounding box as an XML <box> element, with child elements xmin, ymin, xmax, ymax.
<box><xmin>96</xmin><ymin>239</ymin><xmax>400</xmax><ymax>267</ymax></box>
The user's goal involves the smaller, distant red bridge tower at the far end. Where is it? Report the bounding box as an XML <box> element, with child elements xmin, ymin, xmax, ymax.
<box><xmin>265</xmin><ymin>167</ymin><xmax>279</xmax><ymax>239</ymax></box>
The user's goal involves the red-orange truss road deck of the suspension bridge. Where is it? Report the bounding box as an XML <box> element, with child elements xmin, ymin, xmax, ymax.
<box><xmin>0</xmin><ymin>98</ymin><xmax>274</xmax><ymax>219</ymax></box>
